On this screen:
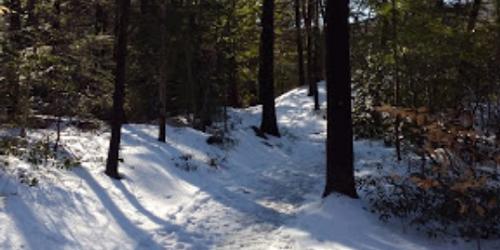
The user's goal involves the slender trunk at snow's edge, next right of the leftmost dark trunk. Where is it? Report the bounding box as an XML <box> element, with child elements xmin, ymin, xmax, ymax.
<box><xmin>158</xmin><ymin>3</ymin><xmax>167</xmax><ymax>142</ymax></box>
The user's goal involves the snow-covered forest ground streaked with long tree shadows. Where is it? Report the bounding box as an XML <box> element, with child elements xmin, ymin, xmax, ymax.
<box><xmin>0</xmin><ymin>84</ymin><xmax>500</xmax><ymax>250</ymax></box>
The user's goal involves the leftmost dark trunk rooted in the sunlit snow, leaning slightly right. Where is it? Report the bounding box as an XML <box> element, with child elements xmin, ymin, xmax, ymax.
<box><xmin>106</xmin><ymin>0</ymin><xmax>130</xmax><ymax>179</ymax></box>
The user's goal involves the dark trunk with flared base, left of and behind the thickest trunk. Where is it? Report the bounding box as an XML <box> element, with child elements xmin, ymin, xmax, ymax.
<box><xmin>259</xmin><ymin>0</ymin><xmax>280</xmax><ymax>136</ymax></box>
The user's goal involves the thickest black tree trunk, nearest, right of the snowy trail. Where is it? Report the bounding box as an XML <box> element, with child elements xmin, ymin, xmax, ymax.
<box><xmin>323</xmin><ymin>0</ymin><xmax>358</xmax><ymax>198</ymax></box>
